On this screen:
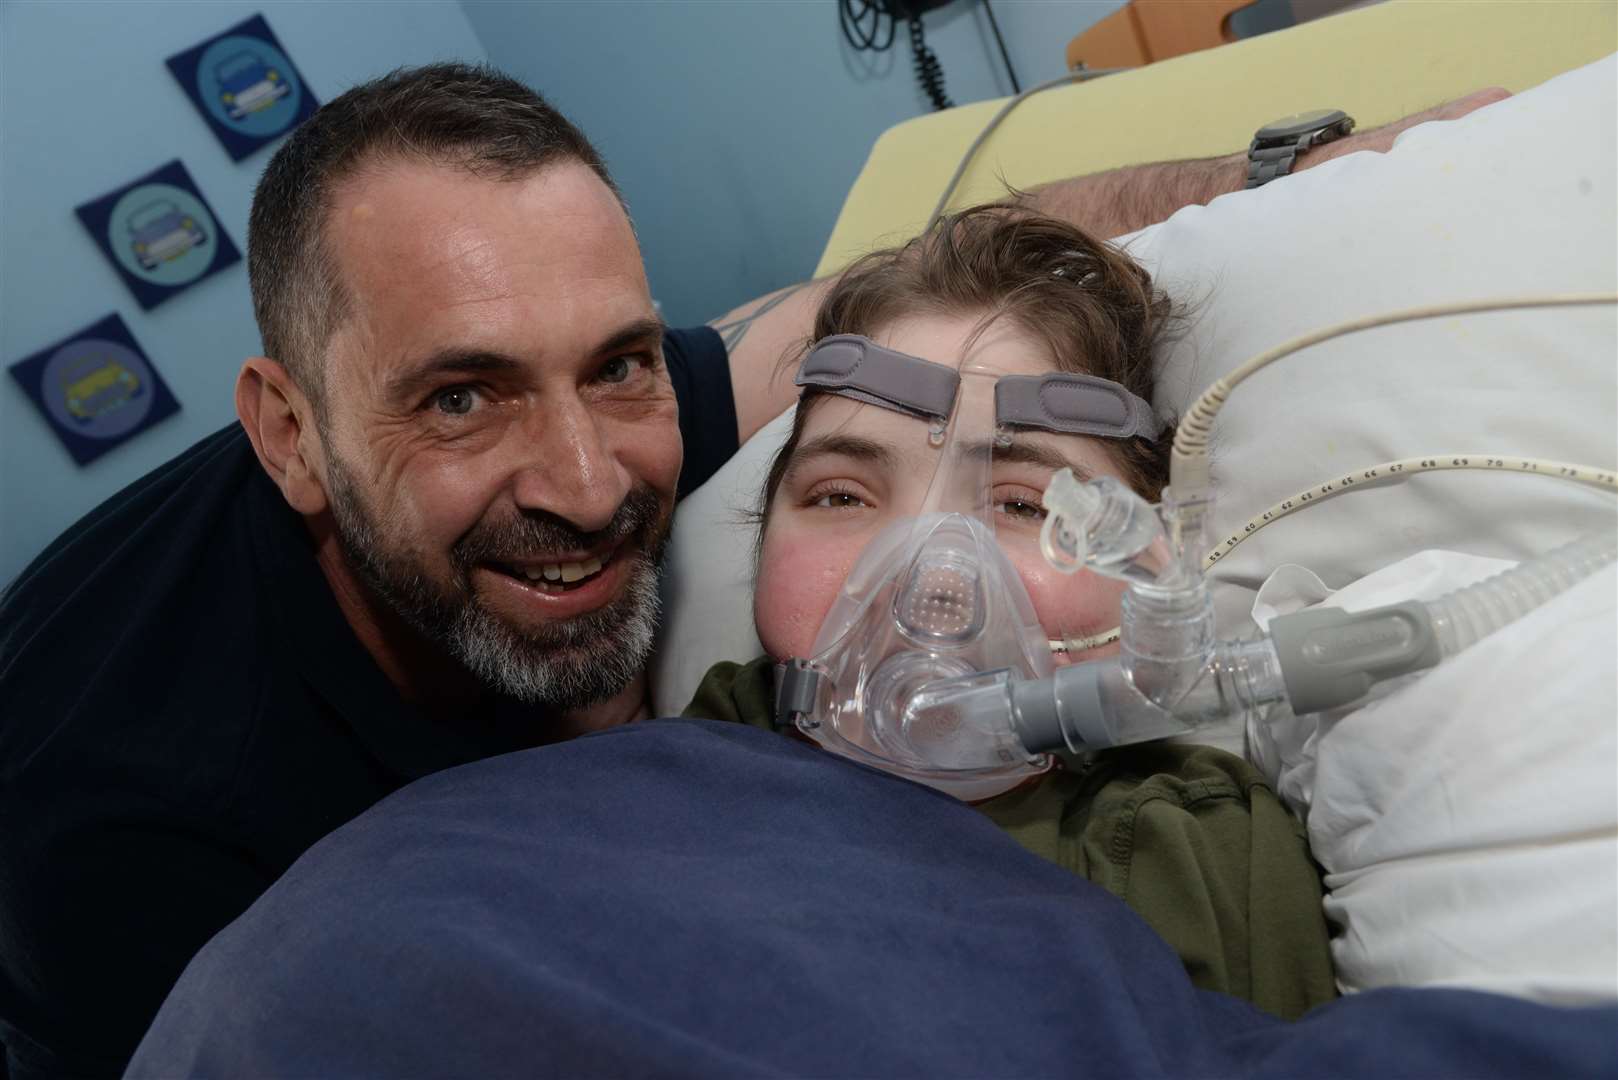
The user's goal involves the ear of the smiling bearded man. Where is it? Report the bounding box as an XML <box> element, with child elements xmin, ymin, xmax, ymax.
<box><xmin>236</xmin><ymin>356</ymin><xmax>328</xmax><ymax>517</ymax></box>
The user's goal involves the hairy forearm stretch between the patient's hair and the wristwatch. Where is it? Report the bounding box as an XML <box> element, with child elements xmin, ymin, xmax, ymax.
<box><xmin>1016</xmin><ymin>154</ymin><xmax>1247</xmax><ymax>236</ymax></box>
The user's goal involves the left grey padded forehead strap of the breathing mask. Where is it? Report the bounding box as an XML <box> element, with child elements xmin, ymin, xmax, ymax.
<box><xmin>793</xmin><ymin>334</ymin><xmax>961</xmax><ymax>419</ymax></box>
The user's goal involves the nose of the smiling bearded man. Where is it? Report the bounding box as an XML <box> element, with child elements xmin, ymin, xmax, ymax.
<box><xmin>513</xmin><ymin>398</ymin><xmax>633</xmax><ymax>533</ymax></box>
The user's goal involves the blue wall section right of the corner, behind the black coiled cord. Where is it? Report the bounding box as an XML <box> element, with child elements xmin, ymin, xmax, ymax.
<box><xmin>463</xmin><ymin>0</ymin><xmax>1123</xmax><ymax>324</ymax></box>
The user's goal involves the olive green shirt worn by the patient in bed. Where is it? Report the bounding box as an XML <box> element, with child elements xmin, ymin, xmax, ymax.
<box><xmin>684</xmin><ymin>657</ymin><xmax>1336</xmax><ymax>1018</ymax></box>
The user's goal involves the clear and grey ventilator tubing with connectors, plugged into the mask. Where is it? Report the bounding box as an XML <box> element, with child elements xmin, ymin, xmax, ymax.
<box><xmin>931</xmin><ymin>474</ymin><xmax>1618</xmax><ymax>753</ymax></box>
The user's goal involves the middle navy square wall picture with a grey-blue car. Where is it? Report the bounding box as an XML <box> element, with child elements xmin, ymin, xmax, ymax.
<box><xmin>74</xmin><ymin>159</ymin><xmax>241</xmax><ymax>311</ymax></box>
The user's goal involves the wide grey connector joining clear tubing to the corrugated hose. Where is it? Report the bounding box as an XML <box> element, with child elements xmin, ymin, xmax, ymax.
<box><xmin>1270</xmin><ymin>601</ymin><xmax>1443</xmax><ymax>716</ymax></box>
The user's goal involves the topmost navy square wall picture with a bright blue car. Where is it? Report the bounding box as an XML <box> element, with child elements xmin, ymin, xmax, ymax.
<box><xmin>168</xmin><ymin>15</ymin><xmax>320</xmax><ymax>162</ymax></box>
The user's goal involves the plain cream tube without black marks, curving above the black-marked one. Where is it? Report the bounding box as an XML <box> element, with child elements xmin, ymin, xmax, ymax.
<box><xmin>1168</xmin><ymin>293</ymin><xmax>1618</xmax><ymax>500</ymax></box>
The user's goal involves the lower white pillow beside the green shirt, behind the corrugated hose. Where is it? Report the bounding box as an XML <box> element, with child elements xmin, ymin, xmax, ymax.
<box><xmin>1251</xmin><ymin>552</ymin><xmax>1618</xmax><ymax>1004</ymax></box>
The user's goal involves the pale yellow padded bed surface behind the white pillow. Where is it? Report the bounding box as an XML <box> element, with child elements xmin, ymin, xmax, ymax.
<box><xmin>815</xmin><ymin>0</ymin><xmax>1618</xmax><ymax>277</ymax></box>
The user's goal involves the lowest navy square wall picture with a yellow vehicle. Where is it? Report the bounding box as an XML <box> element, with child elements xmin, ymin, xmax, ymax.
<box><xmin>11</xmin><ymin>313</ymin><xmax>180</xmax><ymax>465</ymax></box>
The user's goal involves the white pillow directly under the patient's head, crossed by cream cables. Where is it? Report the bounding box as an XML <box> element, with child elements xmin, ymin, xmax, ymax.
<box><xmin>652</xmin><ymin>57</ymin><xmax>1618</xmax><ymax>725</ymax></box>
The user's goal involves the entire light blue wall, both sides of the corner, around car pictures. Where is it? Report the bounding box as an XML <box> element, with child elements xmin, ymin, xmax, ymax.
<box><xmin>0</xmin><ymin>0</ymin><xmax>1121</xmax><ymax>585</ymax></box>
